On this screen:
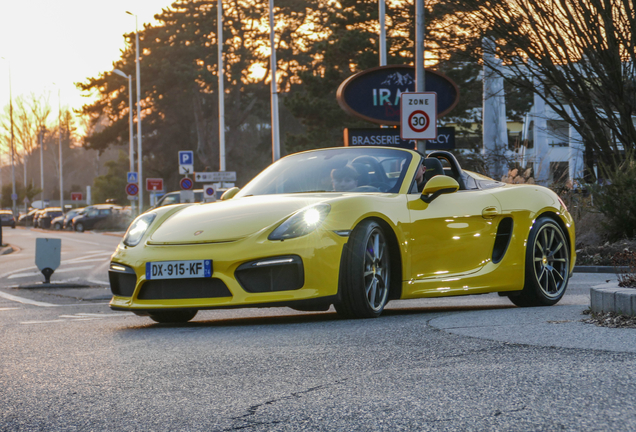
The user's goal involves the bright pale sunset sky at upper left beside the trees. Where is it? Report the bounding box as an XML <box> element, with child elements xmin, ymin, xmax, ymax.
<box><xmin>0</xmin><ymin>0</ymin><xmax>172</xmax><ymax>126</ymax></box>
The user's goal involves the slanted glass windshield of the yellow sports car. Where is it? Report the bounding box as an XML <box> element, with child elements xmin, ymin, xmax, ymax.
<box><xmin>237</xmin><ymin>147</ymin><xmax>412</xmax><ymax>197</ymax></box>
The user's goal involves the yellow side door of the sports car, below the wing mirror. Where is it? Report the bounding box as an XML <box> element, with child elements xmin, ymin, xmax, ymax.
<box><xmin>407</xmin><ymin>191</ymin><xmax>501</xmax><ymax>282</ymax></box>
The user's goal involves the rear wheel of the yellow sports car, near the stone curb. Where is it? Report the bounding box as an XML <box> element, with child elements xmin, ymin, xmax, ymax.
<box><xmin>509</xmin><ymin>217</ymin><xmax>570</xmax><ymax>307</ymax></box>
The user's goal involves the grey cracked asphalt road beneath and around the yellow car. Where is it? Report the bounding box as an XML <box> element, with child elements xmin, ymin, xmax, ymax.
<box><xmin>0</xmin><ymin>230</ymin><xmax>636</xmax><ymax>431</ymax></box>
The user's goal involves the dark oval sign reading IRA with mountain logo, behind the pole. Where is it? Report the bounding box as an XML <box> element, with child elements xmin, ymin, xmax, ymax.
<box><xmin>336</xmin><ymin>65</ymin><xmax>459</xmax><ymax>126</ymax></box>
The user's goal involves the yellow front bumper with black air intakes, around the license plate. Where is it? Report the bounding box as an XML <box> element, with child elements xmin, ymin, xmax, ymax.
<box><xmin>110</xmin><ymin>230</ymin><xmax>347</xmax><ymax>312</ymax></box>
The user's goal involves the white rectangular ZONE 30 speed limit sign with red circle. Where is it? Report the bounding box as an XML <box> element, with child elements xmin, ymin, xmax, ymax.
<box><xmin>400</xmin><ymin>93</ymin><xmax>437</xmax><ymax>140</ymax></box>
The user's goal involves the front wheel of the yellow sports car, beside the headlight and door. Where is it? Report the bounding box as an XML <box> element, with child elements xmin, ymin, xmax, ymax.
<box><xmin>334</xmin><ymin>221</ymin><xmax>391</xmax><ymax>318</ymax></box>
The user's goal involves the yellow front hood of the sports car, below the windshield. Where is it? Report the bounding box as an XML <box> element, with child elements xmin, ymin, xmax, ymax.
<box><xmin>148</xmin><ymin>194</ymin><xmax>341</xmax><ymax>245</ymax></box>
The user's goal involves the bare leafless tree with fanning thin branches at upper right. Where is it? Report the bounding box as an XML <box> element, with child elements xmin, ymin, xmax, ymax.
<box><xmin>450</xmin><ymin>0</ymin><xmax>636</xmax><ymax>177</ymax></box>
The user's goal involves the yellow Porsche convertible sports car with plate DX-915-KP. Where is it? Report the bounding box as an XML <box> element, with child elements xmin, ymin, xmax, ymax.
<box><xmin>109</xmin><ymin>147</ymin><xmax>575</xmax><ymax>322</ymax></box>
